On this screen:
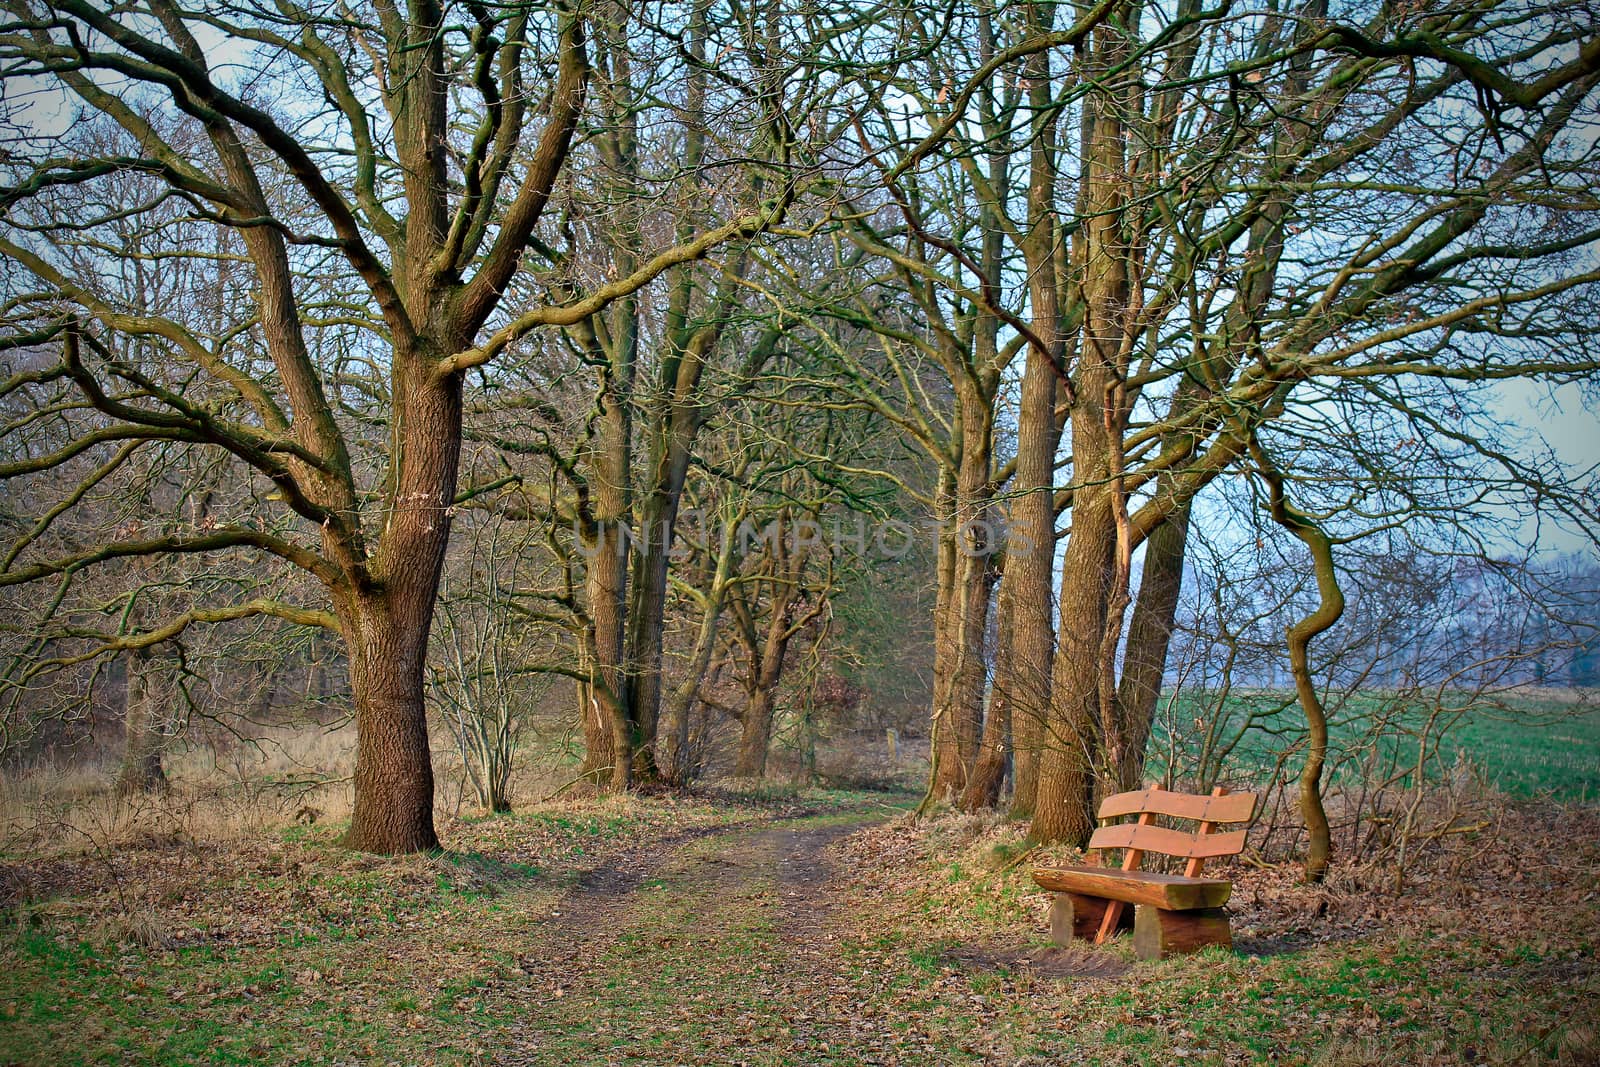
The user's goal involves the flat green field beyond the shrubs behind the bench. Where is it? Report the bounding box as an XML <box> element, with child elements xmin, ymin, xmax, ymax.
<box><xmin>1149</xmin><ymin>691</ymin><xmax>1600</xmax><ymax>803</ymax></box>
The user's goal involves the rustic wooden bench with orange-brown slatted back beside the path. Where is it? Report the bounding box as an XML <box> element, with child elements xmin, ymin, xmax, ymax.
<box><xmin>1034</xmin><ymin>785</ymin><xmax>1256</xmax><ymax>960</ymax></box>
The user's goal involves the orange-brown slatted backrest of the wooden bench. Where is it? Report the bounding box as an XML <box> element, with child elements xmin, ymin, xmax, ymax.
<box><xmin>1090</xmin><ymin>785</ymin><xmax>1256</xmax><ymax>878</ymax></box>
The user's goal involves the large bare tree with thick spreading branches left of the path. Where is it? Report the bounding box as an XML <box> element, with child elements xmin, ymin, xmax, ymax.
<box><xmin>0</xmin><ymin>0</ymin><xmax>795</xmax><ymax>851</ymax></box>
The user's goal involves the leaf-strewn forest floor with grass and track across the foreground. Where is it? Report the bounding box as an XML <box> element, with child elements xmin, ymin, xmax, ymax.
<box><xmin>0</xmin><ymin>790</ymin><xmax>1600</xmax><ymax>1065</ymax></box>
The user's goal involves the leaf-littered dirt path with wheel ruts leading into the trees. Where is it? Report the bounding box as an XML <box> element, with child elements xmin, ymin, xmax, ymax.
<box><xmin>494</xmin><ymin>813</ymin><xmax>915</xmax><ymax>1064</ymax></box>
